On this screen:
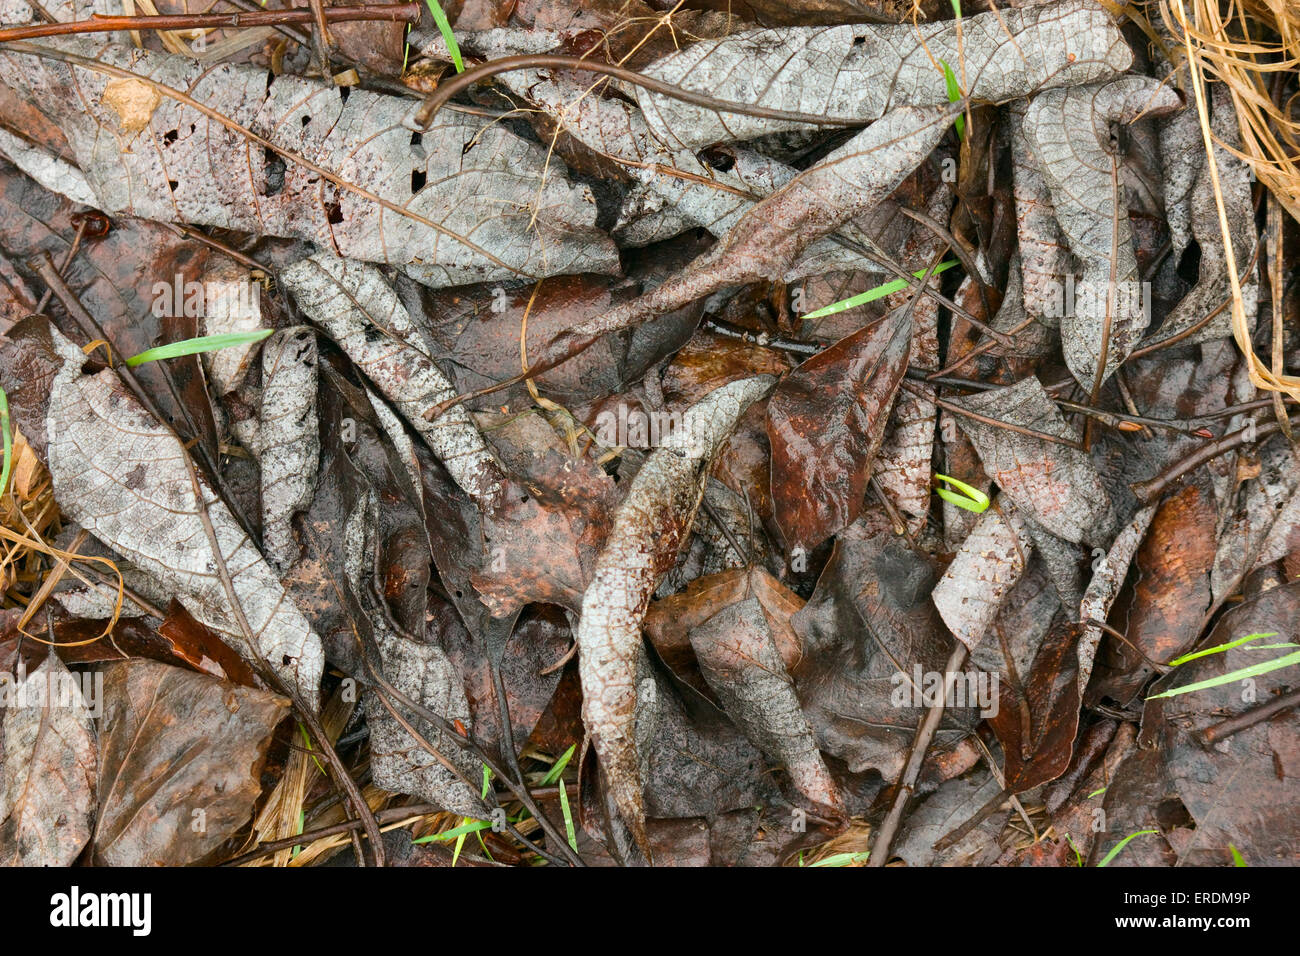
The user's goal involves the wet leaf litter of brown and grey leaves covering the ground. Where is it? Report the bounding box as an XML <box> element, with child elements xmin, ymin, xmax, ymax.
<box><xmin>0</xmin><ymin>0</ymin><xmax>1300</xmax><ymax>866</ymax></box>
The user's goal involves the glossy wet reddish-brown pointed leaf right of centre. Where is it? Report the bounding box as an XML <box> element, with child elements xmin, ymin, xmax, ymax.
<box><xmin>767</xmin><ymin>308</ymin><xmax>911</xmax><ymax>550</ymax></box>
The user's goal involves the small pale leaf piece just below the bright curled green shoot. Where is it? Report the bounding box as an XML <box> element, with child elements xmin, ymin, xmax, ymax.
<box><xmin>931</xmin><ymin>497</ymin><xmax>1034</xmax><ymax>650</ymax></box>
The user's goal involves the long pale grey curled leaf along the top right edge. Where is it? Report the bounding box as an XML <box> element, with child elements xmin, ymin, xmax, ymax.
<box><xmin>636</xmin><ymin>0</ymin><xmax>1132</xmax><ymax>148</ymax></box>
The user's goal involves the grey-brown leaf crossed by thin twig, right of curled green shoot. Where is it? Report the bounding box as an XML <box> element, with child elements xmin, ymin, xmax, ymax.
<box><xmin>957</xmin><ymin>376</ymin><xmax>1114</xmax><ymax>544</ymax></box>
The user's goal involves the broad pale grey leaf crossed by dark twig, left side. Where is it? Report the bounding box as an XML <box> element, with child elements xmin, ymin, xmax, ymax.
<box><xmin>46</xmin><ymin>326</ymin><xmax>324</xmax><ymax>706</ymax></box>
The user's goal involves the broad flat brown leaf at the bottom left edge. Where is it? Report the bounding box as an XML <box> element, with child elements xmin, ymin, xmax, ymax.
<box><xmin>94</xmin><ymin>659</ymin><xmax>289</xmax><ymax>866</ymax></box>
